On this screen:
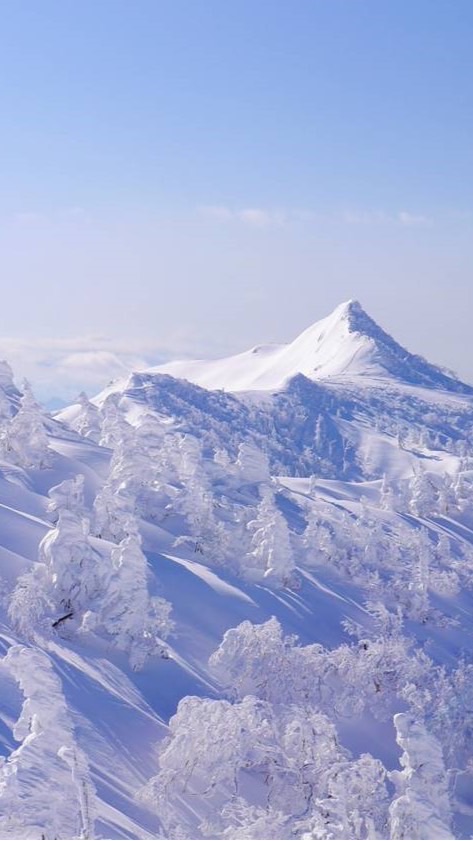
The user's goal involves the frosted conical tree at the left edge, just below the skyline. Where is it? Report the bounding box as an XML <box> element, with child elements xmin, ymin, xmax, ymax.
<box><xmin>2</xmin><ymin>380</ymin><xmax>50</xmax><ymax>468</ymax></box>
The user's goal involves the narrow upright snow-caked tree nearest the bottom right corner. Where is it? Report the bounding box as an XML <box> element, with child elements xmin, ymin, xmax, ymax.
<box><xmin>389</xmin><ymin>713</ymin><xmax>455</xmax><ymax>839</ymax></box>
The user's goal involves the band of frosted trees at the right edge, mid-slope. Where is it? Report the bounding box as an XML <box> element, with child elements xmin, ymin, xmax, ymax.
<box><xmin>297</xmin><ymin>471</ymin><xmax>473</xmax><ymax>622</ymax></box>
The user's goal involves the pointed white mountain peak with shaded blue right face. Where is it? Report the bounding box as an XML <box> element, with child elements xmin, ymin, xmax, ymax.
<box><xmin>152</xmin><ymin>300</ymin><xmax>473</xmax><ymax>394</ymax></box>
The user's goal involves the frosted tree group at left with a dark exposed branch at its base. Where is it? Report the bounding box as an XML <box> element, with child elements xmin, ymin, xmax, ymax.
<box><xmin>9</xmin><ymin>466</ymin><xmax>173</xmax><ymax>668</ymax></box>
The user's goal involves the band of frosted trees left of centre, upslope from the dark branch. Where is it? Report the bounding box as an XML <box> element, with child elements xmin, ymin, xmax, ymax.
<box><xmin>92</xmin><ymin>401</ymin><xmax>295</xmax><ymax>586</ymax></box>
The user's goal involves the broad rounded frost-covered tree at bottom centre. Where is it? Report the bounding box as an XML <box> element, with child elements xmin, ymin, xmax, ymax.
<box><xmin>146</xmin><ymin>644</ymin><xmax>388</xmax><ymax>839</ymax></box>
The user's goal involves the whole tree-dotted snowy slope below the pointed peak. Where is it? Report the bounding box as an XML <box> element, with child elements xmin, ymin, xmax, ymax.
<box><xmin>0</xmin><ymin>334</ymin><xmax>473</xmax><ymax>839</ymax></box>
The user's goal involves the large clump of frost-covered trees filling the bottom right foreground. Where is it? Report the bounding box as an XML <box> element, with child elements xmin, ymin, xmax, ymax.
<box><xmin>143</xmin><ymin>619</ymin><xmax>462</xmax><ymax>839</ymax></box>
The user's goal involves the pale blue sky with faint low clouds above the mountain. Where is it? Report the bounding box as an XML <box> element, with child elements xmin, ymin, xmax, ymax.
<box><xmin>0</xmin><ymin>0</ymin><xmax>473</xmax><ymax>397</ymax></box>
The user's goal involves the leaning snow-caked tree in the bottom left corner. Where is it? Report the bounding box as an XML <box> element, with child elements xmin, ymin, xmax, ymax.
<box><xmin>0</xmin><ymin>645</ymin><xmax>97</xmax><ymax>838</ymax></box>
